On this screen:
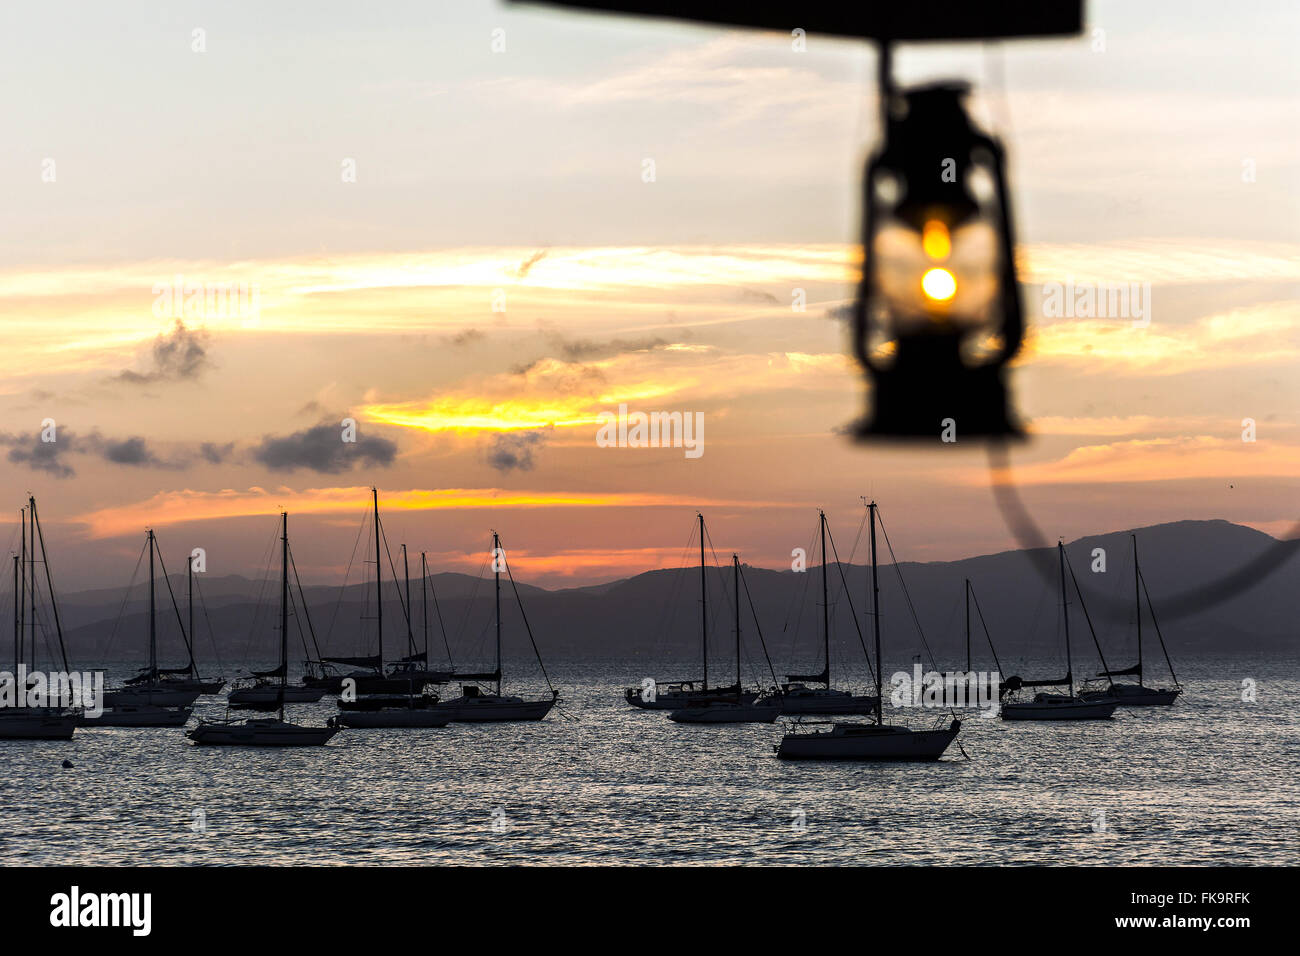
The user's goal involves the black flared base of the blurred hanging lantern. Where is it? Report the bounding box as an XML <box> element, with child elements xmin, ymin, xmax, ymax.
<box><xmin>853</xmin><ymin>338</ymin><xmax>1024</xmax><ymax>444</ymax></box>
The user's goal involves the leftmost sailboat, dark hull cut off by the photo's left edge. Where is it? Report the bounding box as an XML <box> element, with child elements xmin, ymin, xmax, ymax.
<box><xmin>0</xmin><ymin>496</ymin><xmax>79</xmax><ymax>740</ymax></box>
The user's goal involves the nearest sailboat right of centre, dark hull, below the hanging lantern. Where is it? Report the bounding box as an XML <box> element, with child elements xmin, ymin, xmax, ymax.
<box><xmin>774</xmin><ymin>501</ymin><xmax>962</xmax><ymax>761</ymax></box>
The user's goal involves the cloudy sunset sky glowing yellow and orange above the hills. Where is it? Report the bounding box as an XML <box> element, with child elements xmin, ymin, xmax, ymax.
<box><xmin>0</xmin><ymin>0</ymin><xmax>1300</xmax><ymax>589</ymax></box>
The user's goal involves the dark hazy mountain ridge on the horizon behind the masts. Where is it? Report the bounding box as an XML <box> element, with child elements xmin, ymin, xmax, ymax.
<box><xmin>20</xmin><ymin>520</ymin><xmax>1300</xmax><ymax>680</ymax></box>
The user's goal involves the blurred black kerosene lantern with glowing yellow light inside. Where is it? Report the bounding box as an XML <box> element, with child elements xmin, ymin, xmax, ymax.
<box><xmin>853</xmin><ymin>82</ymin><xmax>1024</xmax><ymax>441</ymax></box>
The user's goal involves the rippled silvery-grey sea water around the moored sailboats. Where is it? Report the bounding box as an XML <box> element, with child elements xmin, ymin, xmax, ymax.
<box><xmin>0</xmin><ymin>659</ymin><xmax>1300</xmax><ymax>864</ymax></box>
